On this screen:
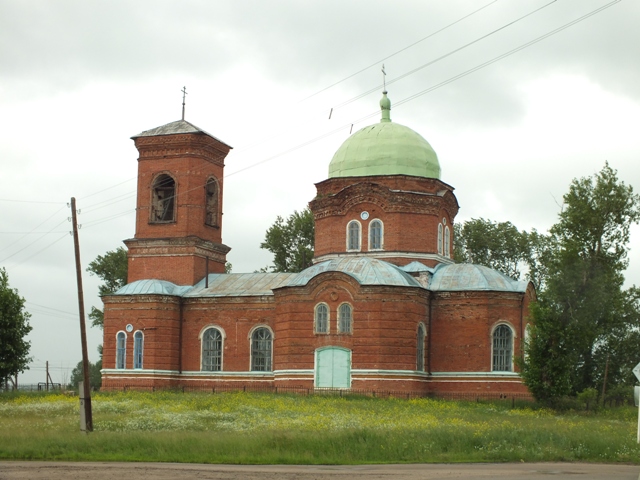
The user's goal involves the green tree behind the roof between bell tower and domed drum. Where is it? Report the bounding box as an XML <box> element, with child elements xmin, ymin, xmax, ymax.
<box><xmin>260</xmin><ymin>207</ymin><xmax>314</xmax><ymax>272</ymax></box>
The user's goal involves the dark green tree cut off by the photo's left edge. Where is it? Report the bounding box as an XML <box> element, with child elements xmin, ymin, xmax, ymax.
<box><xmin>0</xmin><ymin>268</ymin><xmax>32</xmax><ymax>384</ymax></box>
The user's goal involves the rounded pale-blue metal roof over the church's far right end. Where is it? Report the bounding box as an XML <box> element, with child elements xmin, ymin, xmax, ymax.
<box><xmin>429</xmin><ymin>263</ymin><xmax>528</xmax><ymax>293</ymax></box>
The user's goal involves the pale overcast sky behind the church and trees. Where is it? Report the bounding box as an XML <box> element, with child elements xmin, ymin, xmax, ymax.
<box><xmin>0</xmin><ymin>0</ymin><xmax>640</xmax><ymax>383</ymax></box>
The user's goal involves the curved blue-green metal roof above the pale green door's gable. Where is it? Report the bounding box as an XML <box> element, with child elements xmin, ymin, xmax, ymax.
<box><xmin>283</xmin><ymin>256</ymin><xmax>422</xmax><ymax>288</ymax></box>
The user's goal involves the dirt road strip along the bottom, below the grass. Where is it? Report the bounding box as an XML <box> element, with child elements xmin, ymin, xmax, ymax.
<box><xmin>0</xmin><ymin>462</ymin><xmax>640</xmax><ymax>480</ymax></box>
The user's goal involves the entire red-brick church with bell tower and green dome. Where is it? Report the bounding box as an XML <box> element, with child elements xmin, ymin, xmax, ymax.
<box><xmin>102</xmin><ymin>92</ymin><xmax>535</xmax><ymax>397</ymax></box>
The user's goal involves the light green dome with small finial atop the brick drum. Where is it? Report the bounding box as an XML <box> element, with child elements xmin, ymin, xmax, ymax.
<box><xmin>329</xmin><ymin>92</ymin><xmax>440</xmax><ymax>179</ymax></box>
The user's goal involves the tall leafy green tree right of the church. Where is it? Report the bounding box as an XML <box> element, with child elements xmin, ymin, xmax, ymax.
<box><xmin>522</xmin><ymin>164</ymin><xmax>640</xmax><ymax>401</ymax></box>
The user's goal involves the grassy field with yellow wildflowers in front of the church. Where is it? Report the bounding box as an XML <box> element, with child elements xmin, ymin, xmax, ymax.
<box><xmin>0</xmin><ymin>392</ymin><xmax>640</xmax><ymax>464</ymax></box>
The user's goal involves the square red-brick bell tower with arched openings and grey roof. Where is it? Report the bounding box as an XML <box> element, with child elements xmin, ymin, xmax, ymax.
<box><xmin>124</xmin><ymin>120</ymin><xmax>232</xmax><ymax>285</ymax></box>
